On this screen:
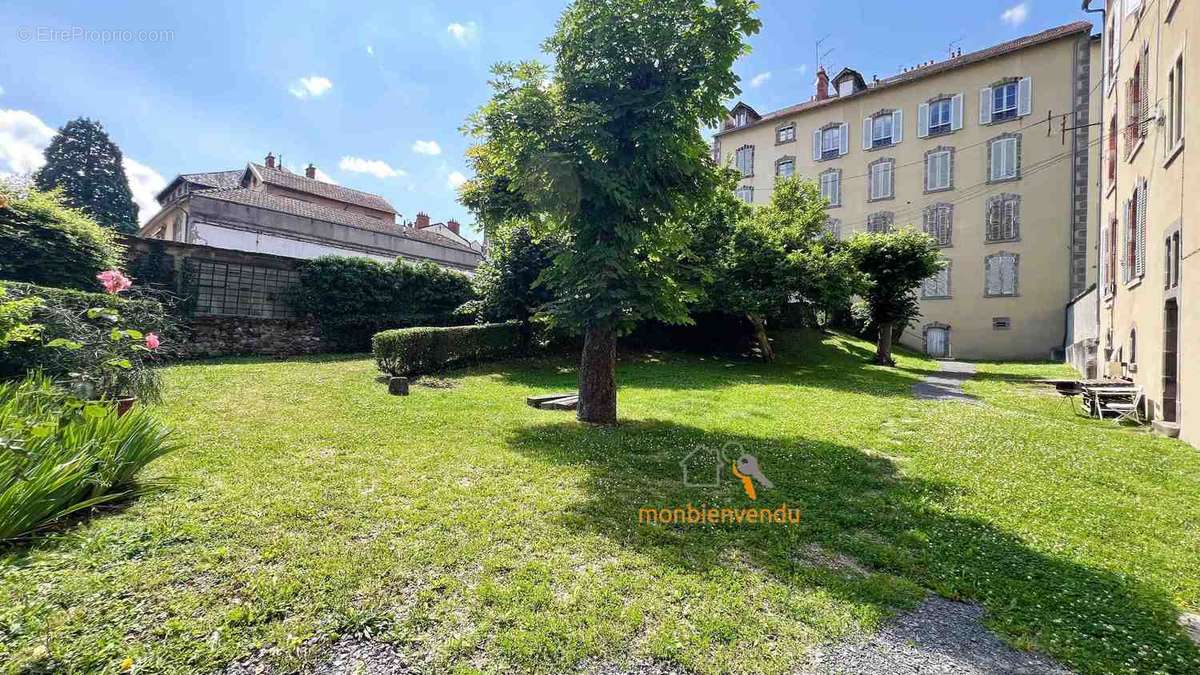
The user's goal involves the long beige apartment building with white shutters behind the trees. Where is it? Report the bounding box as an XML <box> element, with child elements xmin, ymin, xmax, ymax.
<box><xmin>713</xmin><ymin>22</ymin><xmax>1100</xmax><ymax>359</ymax></box>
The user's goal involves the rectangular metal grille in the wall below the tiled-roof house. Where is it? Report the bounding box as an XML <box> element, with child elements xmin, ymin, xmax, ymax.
<box><xmin>185</xmin><ymin>258</ymin><xmax>299</xmax><ymax>318</ymax></box>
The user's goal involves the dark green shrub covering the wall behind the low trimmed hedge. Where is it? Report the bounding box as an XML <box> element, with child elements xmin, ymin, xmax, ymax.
<box><xmin>289</xmin><ymin>256</ymin><xmax>474</xmax><ymax>351</ymax></box>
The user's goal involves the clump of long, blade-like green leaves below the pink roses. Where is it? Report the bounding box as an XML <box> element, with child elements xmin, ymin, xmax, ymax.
<box><xmin>0</xmin><ymin>376</ymin><xmax>175</xmax><ymax>542</ymax></box>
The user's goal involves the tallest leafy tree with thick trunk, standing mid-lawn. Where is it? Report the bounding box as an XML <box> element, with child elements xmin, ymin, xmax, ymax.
<box><xmin>462</xmin><ymin>0</ymin><xmax>760</xmax><ymax>424</ymax></box>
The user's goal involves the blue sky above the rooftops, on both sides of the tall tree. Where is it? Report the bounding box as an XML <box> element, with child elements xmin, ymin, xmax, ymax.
<box><xmin>0</xmin><ymin>0</ymin><xmax>1091</xmax><ymax>239</ymax></box>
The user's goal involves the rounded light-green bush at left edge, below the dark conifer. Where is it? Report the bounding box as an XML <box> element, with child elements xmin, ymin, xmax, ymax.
<box><xmin>0</xmin><ymin>181</ymin><xmax>122</xmax><ymax>291</ymax></box>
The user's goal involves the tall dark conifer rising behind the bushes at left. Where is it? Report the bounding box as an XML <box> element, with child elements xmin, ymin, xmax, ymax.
<box><xmin>34</xmin><ymin>118</ymin><xmax>138</xmax><ymax>234</ymax></box>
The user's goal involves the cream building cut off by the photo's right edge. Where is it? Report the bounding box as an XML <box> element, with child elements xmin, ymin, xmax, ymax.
<box><xmin>1084</xmin><ymin>0</ymin><xmax>1200</xmax><ymax>444</ymax></box>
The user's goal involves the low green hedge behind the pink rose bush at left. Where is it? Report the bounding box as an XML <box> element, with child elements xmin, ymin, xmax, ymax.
<box><xmin>0</xmin><ymin>281</ymin><xmax>180</xmax><ymax>378</ymax></box>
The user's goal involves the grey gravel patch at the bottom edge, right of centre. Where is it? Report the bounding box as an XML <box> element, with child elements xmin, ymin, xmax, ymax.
<box><xmin>802</xmin><ymin>597</ymin><xmax>1070</xmax><ymax>675</ymax></box>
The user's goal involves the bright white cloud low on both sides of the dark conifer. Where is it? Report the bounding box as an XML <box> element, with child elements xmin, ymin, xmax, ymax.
<box><xmin>0</xmin><ymin>110</ymin><xmax>167</xmax><ymax>223</ymax></box>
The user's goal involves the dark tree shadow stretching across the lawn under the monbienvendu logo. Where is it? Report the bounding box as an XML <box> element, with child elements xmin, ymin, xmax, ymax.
<box><xmin>508</xmin><ymin>420</ymin><xmax>1200</xmax><ymax>673</ymax></box>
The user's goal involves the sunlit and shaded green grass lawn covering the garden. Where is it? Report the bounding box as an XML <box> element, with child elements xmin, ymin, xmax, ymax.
<box><xmin>0</xmin><ymin>333</ymin><xmax>1200</xmax><ymax>673</ymax></box>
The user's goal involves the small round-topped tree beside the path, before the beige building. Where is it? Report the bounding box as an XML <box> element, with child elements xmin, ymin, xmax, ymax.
<box><xmin>848</xmin><ymin>228</ymin><xmax>944</xmax><ymax>365</ymax></box>
